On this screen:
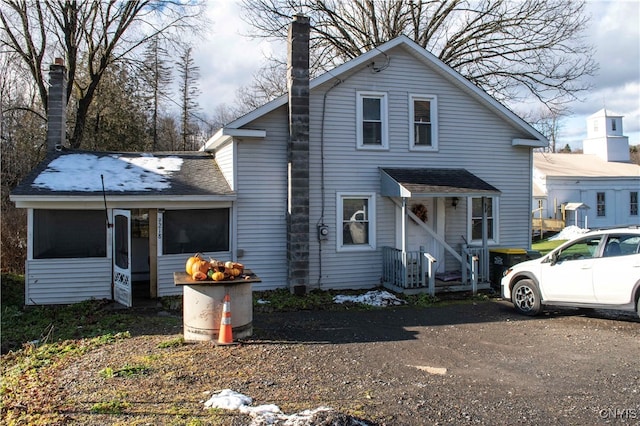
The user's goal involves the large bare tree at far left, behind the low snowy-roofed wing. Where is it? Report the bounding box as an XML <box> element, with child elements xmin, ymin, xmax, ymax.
<box><xmin>0</xmin><ymin>0</ymin><xmax>202</xmax><ymax>148</ymax></box>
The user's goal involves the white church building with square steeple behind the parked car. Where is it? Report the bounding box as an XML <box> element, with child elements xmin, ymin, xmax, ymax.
<box><xmin>532</xmin><ymin>109</ymin><xmax>640</xmax><ymax>228</ymax></box>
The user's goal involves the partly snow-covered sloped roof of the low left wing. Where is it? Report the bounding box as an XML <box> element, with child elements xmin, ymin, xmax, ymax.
<box><xmin>11</xmin><ymin>150</ymin><xmax>235</xmax><ymax>205</ymax></box>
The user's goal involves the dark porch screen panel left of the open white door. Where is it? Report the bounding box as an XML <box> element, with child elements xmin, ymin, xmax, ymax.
<box><xmin>33</xmin><ymin>210</ymin><xmax>107</xmax><ymax>259</ymax></box>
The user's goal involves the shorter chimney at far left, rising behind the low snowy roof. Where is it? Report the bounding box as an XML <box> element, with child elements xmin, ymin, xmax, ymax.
<box><xmin>47</xmin><ymin>58</ymin><xmax>67</xmax><ymax>152</ymax></box>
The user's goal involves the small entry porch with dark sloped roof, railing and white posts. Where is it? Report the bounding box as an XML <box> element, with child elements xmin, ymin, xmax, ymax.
<box><xmin>381</xmin><ymin>168</ymin><xmax>500</xmax><ymax>295</ymax></box>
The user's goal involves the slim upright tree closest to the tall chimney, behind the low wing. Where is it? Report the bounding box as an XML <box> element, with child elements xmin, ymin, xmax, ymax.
<box><xmin>176</xmin><ymin>46</ymin><xmax>200</xmax><ymax>151</ymax></box>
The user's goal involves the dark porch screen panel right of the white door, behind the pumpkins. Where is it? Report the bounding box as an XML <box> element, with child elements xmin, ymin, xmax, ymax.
<box><xmin>162</xmin><ymin>208</ymin><xmax>230</xmax><ymax>254</ymax></box>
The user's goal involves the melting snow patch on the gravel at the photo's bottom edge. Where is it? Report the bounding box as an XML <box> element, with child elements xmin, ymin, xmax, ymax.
<box><xmin>204</xmin><ymin>389</ymin><xmax>342</xmax><ymax>426</ymax></box>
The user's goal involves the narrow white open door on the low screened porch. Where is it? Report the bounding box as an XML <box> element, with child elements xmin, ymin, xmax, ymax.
<box><xmin>112</xmin><ymin>210</ymin><xmax>133</xmax><ymax>307</ymax></box>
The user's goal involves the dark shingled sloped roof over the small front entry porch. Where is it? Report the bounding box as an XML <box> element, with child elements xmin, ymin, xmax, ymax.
<box><xmin>380</xmin><ymin>168</ymin><xmax>500</xmax><ymax>198</ymax></box>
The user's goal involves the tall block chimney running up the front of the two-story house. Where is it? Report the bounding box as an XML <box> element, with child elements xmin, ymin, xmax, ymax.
<box><xmin>287</xmin><ymin>15</ymin><xmax>310</xmax><ymax>294</ymax></box>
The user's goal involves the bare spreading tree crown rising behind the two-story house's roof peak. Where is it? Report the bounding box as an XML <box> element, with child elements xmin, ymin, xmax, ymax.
<box><xmin>242</xmin><ymin>0</ymin><xmax>597</xmax><ymax>107</ymax></box>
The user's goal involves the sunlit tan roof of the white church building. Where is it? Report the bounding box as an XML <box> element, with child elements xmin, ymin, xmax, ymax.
<box><xmin>533</xmin><ymin>152</ymin><xmax>640</xmax><ymax>178</ymax></box>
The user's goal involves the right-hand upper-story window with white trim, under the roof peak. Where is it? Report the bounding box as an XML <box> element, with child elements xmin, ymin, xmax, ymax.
<box><xmin>409</xmin><ymin>95</ymin><xmax>438</xmax><ymax>151</ymax></box>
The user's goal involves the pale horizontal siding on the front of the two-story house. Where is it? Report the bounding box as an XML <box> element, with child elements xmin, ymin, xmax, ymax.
<box><xmin>228</xmin><ymin>44</ymin><xmax>531</xmax><ymax>290</ymax></box>
